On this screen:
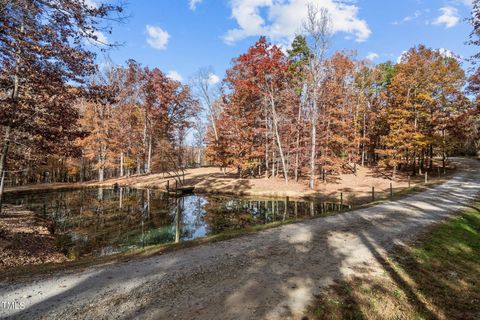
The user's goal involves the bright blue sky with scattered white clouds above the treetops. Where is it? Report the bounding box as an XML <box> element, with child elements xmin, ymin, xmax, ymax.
<box><xmin>93</xmin><ymin>0</ymin><xmax>475</xmax><ymax>83</ymax></box>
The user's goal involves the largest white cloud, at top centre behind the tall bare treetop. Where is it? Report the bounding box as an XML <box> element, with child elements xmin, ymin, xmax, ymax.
<box><xmin>223</xmin><ymin>0</ymin><xmax>371</xmax><ymax>44</ymax></box>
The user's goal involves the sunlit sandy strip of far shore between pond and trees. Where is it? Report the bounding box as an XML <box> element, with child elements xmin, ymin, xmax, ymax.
<box><xmin>4</xmin><ymin>162</ymin><xmax>457</xmax><ymax>200</ymax></box>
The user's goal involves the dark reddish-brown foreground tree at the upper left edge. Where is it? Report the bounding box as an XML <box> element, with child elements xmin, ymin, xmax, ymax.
<box><xmin>0</xmin><ymin>0</ymin><xmax>122</xmax><ymax>212</ymax></box>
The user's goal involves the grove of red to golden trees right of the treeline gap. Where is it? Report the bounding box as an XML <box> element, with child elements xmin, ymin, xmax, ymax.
<box><xmin>207</xmin><ymin>36</ymin><xmax>477</xmax><ymax>187</ymax></box>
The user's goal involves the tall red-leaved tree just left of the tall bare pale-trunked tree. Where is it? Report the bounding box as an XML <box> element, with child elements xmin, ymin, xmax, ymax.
<box><xmin>210</xmin><ymin>37</ymin><xmax>294</xmax><ymax>182</ymax></box>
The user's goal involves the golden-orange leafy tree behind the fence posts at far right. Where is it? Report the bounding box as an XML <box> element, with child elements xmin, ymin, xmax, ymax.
<box><xmin>378</xmin><ymin>45</ymin><xmax>466</xmax><ymax>178</ymax></box>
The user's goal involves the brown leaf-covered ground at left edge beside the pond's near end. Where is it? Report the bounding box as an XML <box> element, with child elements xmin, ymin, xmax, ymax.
<box><xmin>0</xmin><ymin>206</ymin><xmax>68</xmax><ymax>269</ymax></box>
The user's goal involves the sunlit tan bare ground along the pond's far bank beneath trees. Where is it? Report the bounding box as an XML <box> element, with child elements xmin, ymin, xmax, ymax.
<box><xmin>6</xmin><ymin>162</ymin><xmax>453</xmax><ymax>198</ymax></box>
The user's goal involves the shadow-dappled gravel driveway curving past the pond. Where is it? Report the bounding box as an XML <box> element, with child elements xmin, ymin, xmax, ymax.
<box><xmin>0</xmin><ymin>159</ymin><xmax>480</xmax><ymax>319</ymax></box>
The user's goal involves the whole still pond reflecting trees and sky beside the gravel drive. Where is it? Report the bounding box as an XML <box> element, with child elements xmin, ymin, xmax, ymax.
<box><xmin>5</xmin><ymin>188</ymin><xmax>346</xmax><ymax>259</ymax></box>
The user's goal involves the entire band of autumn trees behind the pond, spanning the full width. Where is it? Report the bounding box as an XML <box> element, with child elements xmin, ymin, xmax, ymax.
<box><xmin>0</xmin><ymin>0</ymin><xmax>480</xmax><ymax>202</ymax></box>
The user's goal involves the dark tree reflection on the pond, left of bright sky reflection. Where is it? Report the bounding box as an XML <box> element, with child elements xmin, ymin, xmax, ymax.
<box><xmin>6</xmin><ymin>188</ymin><xmax>174</xmax><ymax>258</ymax></box>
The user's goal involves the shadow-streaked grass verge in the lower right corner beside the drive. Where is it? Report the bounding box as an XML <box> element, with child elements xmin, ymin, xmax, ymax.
<box><xmin>308</xmin><ymin>202</ymin><xmax>480</xmax><ymax>319</ymax></box>
